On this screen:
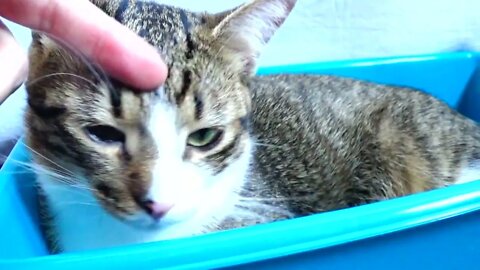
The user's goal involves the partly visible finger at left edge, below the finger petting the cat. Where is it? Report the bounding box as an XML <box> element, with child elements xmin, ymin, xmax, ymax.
<box><xmin>0</xmin><ymin>20</ymin><xmax>27</xmax><ymax>104</ymax></box>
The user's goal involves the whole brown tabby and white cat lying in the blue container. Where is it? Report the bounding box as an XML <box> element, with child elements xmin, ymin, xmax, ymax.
<box><xmin>25</xmin><ymin>0</ymin><xmax>480</xmax><ymax>253</ymax></box>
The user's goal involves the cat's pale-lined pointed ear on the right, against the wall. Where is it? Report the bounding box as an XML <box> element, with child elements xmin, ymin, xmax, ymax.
<box><xmin>212</xmin><ymin>0</ymin><xmax>297</xmax><ymax>75</ymax></box>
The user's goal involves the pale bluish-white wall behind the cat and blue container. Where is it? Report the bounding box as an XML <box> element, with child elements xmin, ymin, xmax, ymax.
<box><xmin>0</xmin><ymin>0</ymin><xmax>480</xmax><ymax>158</ymax></box>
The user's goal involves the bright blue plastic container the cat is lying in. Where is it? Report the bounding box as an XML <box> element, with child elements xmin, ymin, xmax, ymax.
<box><xmin>0</xmin><ymin>53</ymin><xmax>480</xmax><ymax>270</ymax></box>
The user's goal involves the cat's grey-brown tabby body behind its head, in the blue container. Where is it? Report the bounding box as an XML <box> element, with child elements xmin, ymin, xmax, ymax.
<box><xmin>246</xmin><ymin>75</ymin><xmax>480</xmax><ymax>213</ymax></box>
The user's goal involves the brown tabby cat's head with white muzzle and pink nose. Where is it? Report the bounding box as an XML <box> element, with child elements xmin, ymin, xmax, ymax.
<box><xmin>26</xmin><ymin>0</ymin><xmax>296</xmax><ymax>234</ymax></box>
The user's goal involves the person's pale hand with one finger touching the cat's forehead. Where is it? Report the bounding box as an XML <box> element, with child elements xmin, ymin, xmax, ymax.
<box><xmin>0</xmin><ymin>0</ymin><xmax>167</xmax><ymax>104</ymax></box>
